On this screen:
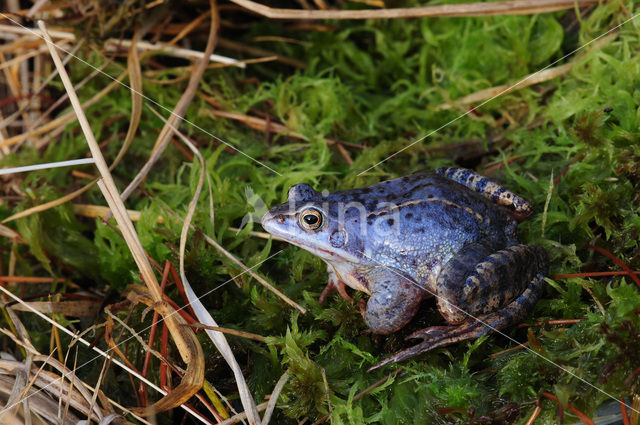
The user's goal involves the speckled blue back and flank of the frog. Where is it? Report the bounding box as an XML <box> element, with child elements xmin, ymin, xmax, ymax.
<box><xmin>340</xmin><ymin>173</ymin><xmax>515</xmax><ymax>281</ymax></box>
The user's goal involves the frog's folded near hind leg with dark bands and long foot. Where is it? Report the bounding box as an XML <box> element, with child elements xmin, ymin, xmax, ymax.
<box><xmin>369</xmin><ymin>244</ymin><xmax>547</xmax><ymax>370</ymax></box>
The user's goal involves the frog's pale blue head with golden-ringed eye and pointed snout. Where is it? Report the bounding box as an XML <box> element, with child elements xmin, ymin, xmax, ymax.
<box><xmin>262</xmin><ymin>183</ymin><xmax>362</xmax><ymax>264</ymax></box>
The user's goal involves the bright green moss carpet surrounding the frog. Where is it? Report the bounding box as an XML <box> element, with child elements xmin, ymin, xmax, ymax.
<box><xmin>0</xmin><ymin>0</ymin><xmax>640</xmax><ymax>424</ymax></box>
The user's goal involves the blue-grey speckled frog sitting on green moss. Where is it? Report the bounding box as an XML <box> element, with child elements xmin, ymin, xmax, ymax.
<box><xmin>261</xmin><ymin>167</ymin><xmax>548</xmax><ymax>370</ymax></box>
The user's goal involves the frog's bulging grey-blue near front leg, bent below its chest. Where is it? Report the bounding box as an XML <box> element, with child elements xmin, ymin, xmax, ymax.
<box><xmin>365</xmin><ymin>267</ymin><xmax>426</xmax><ymax>334</ymax></box>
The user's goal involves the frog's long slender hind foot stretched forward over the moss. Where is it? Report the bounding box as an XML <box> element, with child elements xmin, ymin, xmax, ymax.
<box><xmin>368</xmin><ymin>273</ymin><xmax>544</xmax><ymax>372</ymax></box>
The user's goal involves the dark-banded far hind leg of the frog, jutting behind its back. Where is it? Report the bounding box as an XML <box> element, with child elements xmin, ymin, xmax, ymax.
<box><xmin>435</xmin><ymin>168</ymin><xmax>533</xmax><ymax>221</ymax></box>
